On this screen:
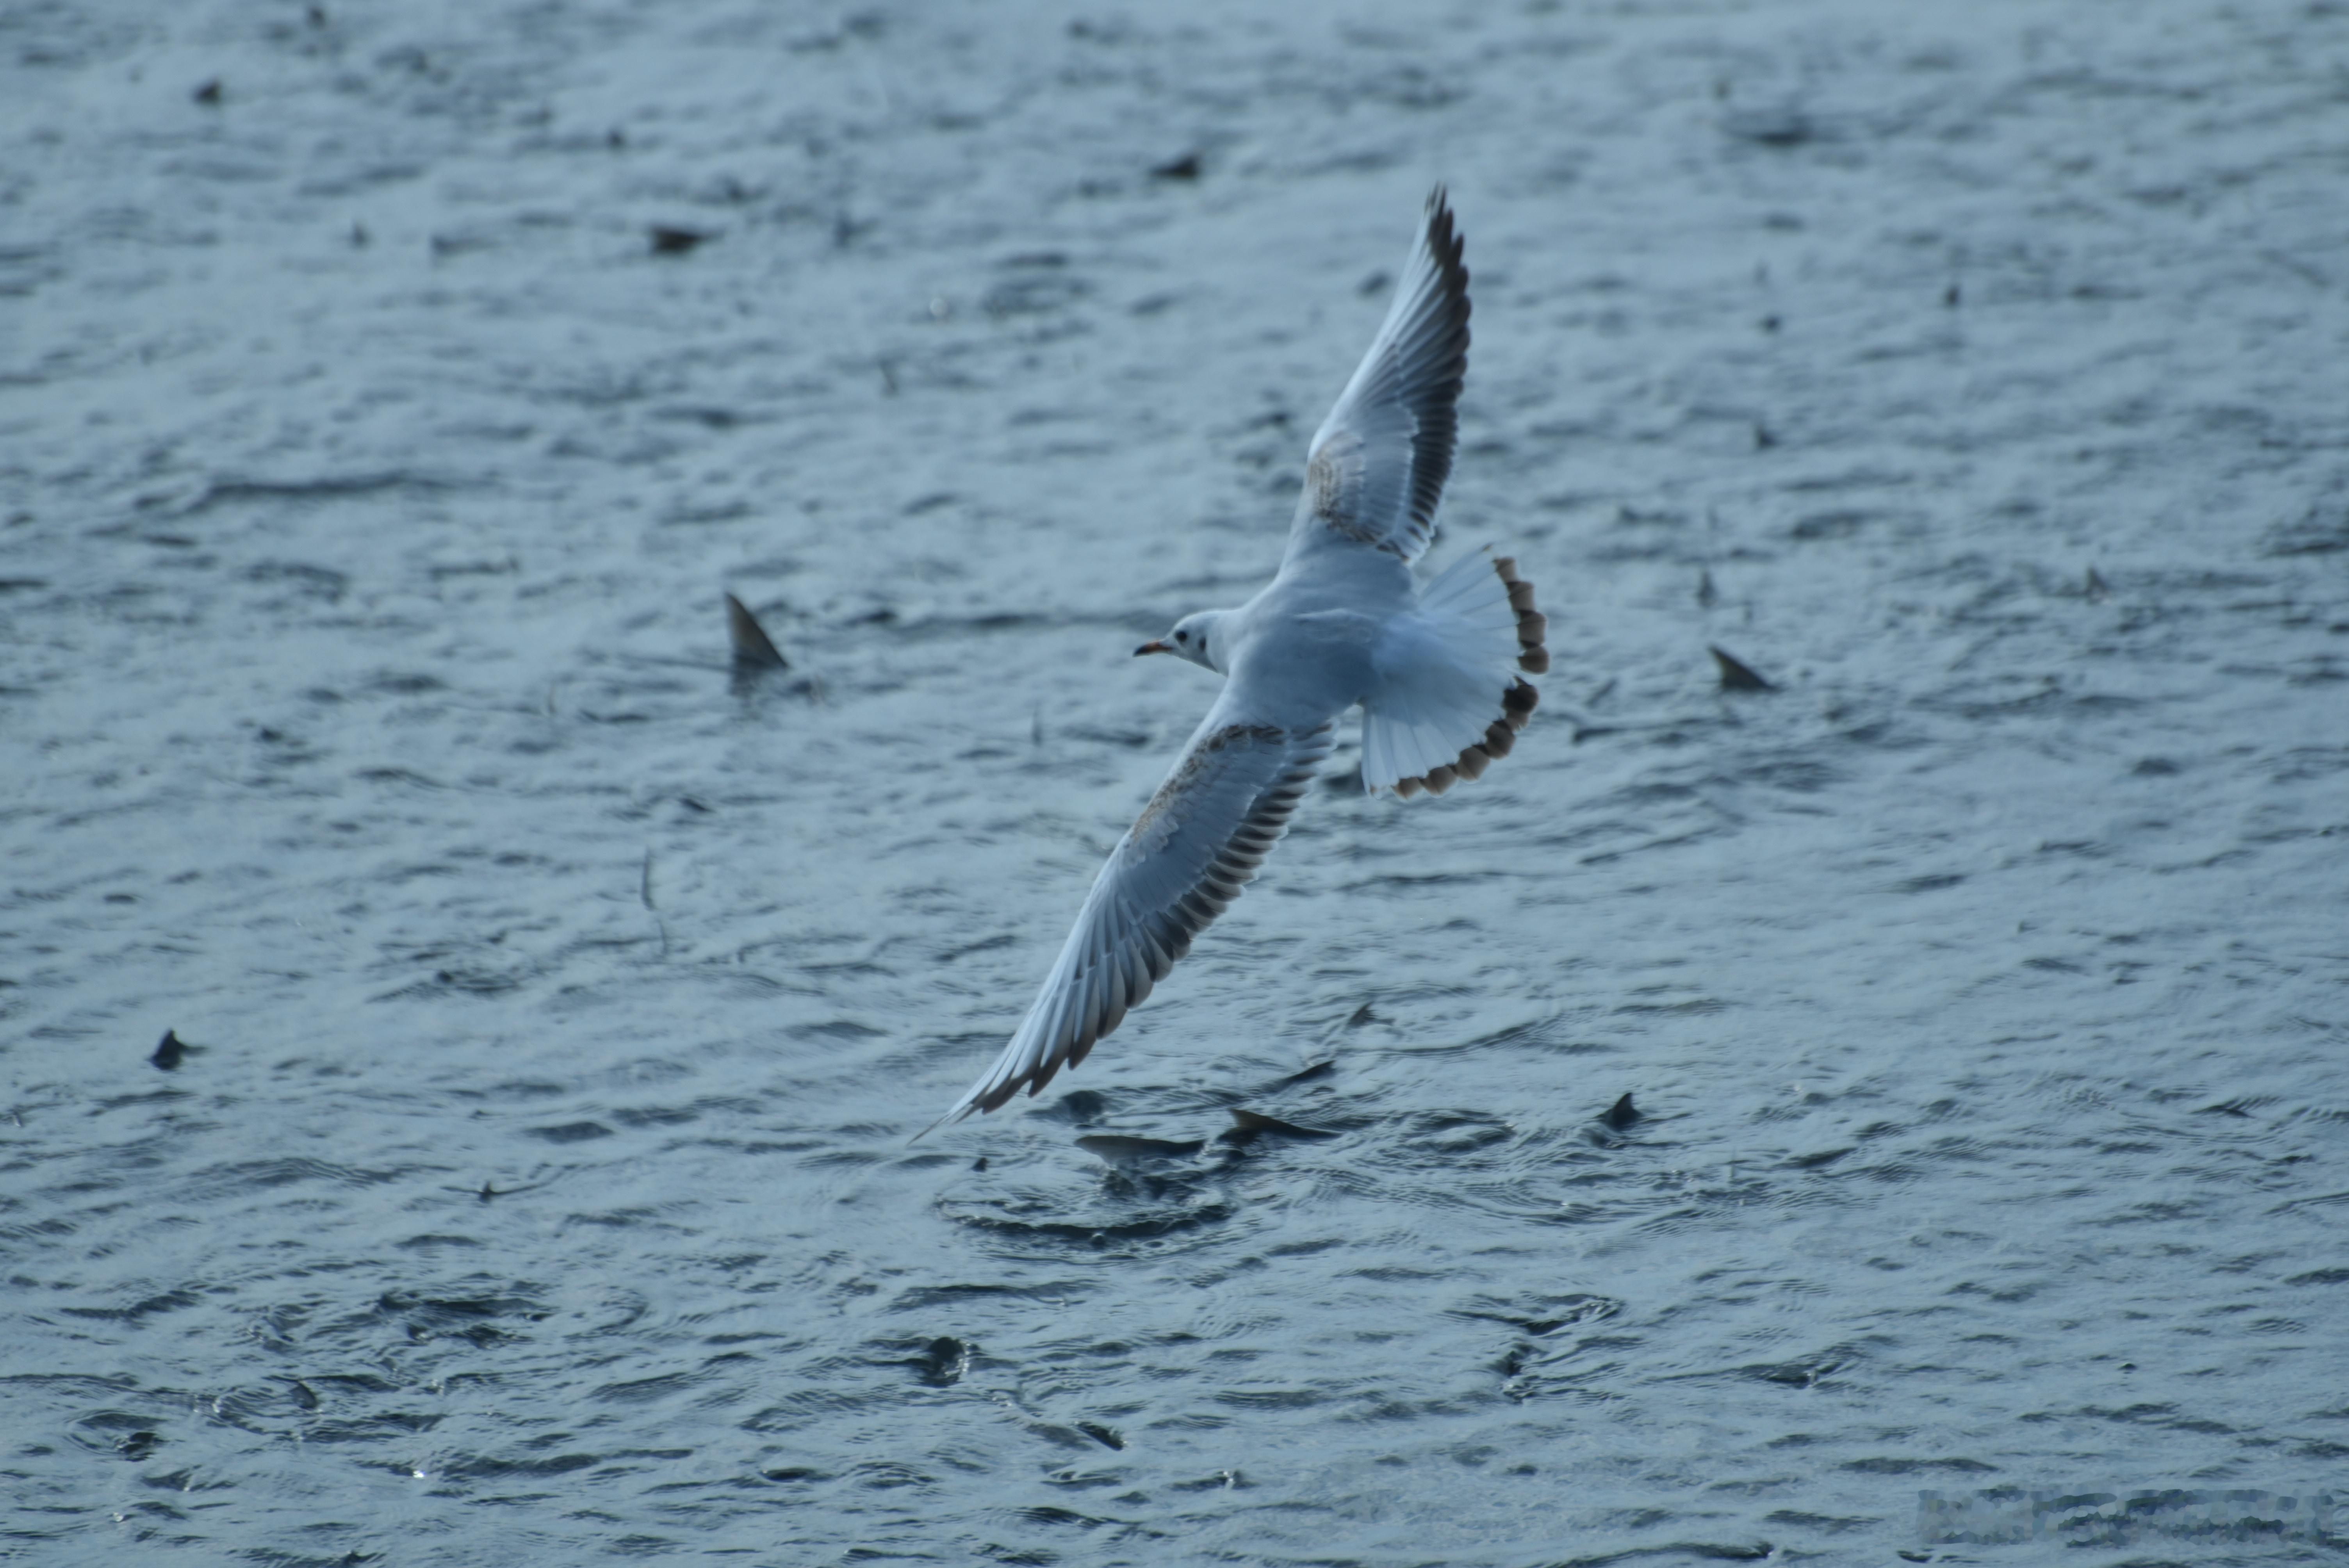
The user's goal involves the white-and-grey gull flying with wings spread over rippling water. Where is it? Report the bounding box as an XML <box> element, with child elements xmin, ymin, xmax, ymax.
<box><xmin>932</xmin><ymin>185</ymin><xmax>1551</xmax><ymax>1127</ymax></box>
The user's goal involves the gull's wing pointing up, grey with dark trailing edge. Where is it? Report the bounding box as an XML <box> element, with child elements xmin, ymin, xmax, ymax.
<box><xmin>1290</xmin><ymin>185</ymin><xmax>1468</xmax><ymax>561</ymax></box>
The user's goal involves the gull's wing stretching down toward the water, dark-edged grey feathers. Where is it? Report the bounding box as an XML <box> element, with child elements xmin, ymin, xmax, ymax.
<box><xmin>939</xmin><ymin>685</ymin><xmax>1334</xmax><ymax>1122</ymax></box>
